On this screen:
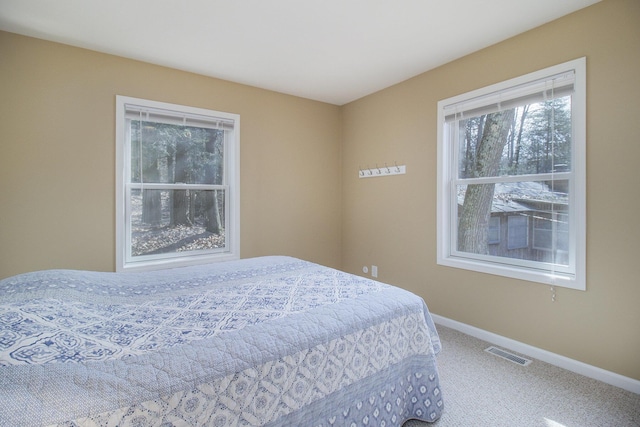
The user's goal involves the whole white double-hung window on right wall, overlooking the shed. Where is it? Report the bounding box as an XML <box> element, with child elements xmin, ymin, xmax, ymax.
<box><xmin>437</xmin><ymin>58</ymin><xmax>586</xmax><ymax>290</ymax></box>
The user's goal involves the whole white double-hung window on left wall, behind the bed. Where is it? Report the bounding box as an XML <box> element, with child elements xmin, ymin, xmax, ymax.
<box><xmin>116</xmin><ymin>96</ymin><xmax>240</xmax><ymax>271</ymax></box>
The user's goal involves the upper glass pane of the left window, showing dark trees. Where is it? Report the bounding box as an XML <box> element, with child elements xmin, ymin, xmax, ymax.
<box><xmin>131</xmin><ymin>120</ymin><xmax>224</xmax><ymax>185</ymax></box>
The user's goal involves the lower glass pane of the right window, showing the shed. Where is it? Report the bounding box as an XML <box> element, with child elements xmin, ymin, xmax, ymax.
<box><xmin>457</xmin><ymin>180</ymin><xmax>569</xmax><ymax>265</ymax></box>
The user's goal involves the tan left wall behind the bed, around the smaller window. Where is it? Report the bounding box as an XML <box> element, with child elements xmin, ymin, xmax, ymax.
<box><xmin>0</xmin><ymin>32</ymin><xmax>341</xmax><ymax>278</ymax></box>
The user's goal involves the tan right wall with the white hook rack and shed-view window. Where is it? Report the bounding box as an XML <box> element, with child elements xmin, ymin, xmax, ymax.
<box><xmin>342</xmin><ymin>0</ymin><xmax>640</xmax><ymax>379</ymax></box>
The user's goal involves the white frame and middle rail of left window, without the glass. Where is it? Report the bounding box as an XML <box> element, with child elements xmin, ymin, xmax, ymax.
<box><xmin>115</xmin><ymin>95</ymin><xmax>240</xmax><ymax>272</ymax></box>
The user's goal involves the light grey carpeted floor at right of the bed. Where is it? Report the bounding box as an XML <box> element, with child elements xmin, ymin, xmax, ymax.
<box><xmin>404</xmin><ymin>325</ymin><xmax>640</xmax><ymax>427</ymax></box>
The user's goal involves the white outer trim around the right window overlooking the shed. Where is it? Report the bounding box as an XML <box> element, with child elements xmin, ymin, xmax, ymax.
<box><xmin>437</xmin><ymin>58</ymin><xmax>586</xmax><ymax>290</ymax></box>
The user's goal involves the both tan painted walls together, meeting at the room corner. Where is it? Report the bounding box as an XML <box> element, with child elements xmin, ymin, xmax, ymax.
<box><xmin>0</xmin><ymin>0</ymin><xmax>640</xmax><ymax>379</ymax></box>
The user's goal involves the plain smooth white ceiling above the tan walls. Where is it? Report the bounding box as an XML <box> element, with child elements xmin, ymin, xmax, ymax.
<box><xmin>0</xmin><ymin>0</ymin><xmax>599</xmax><ymax>105</ymax></box>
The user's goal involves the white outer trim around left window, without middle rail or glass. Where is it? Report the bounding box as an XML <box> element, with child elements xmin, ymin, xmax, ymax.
<box><xmin>115</xmin><ymin>95</ymin><xmax>240</xmax><ymax>272</ymax></box>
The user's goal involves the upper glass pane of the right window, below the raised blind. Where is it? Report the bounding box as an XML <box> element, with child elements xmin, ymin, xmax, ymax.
<box><xmin>452</xmin><ymin>96</ymin><xmax>571</xmax><ymax>178</ymax></box>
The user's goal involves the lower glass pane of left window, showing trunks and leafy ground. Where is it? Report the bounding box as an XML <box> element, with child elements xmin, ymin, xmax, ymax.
<box><xmin>130</xmin><ymin>189</ymin><xmax>226</xmax><ymax>257</ymax></box>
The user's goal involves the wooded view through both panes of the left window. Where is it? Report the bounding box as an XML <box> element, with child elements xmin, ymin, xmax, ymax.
<box><xmin>131</xmin><ymin>120</ymin><xmax>225</xmax><ymax>256</ymax></box>
